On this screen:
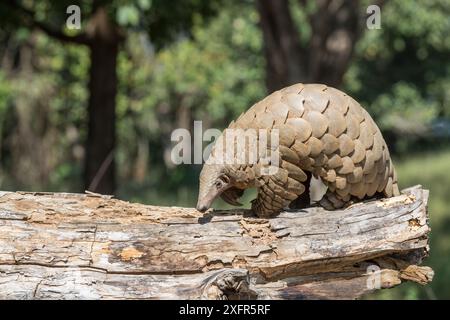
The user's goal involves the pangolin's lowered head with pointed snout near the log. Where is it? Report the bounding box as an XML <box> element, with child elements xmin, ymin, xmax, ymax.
<box><xmin>197</xmin><ymin>163</ymin><xmax>244</xmax><ymax>212</ymax></box>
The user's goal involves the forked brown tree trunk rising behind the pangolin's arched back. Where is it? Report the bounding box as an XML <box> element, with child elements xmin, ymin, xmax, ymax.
<box><xmin>257</xmin><ymin>0</ymin><xmax>365</xmax><ymax>92</ymax></box>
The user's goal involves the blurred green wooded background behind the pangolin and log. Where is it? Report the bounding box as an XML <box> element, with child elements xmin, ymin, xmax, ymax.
<box><xmin>0</xmin><ymin>0</ymin><xmax>450</xmax><ymax>299</ymax></box>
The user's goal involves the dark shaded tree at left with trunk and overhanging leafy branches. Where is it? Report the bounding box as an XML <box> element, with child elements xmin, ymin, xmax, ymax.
<box><xmin>0</xmin><ymin>0</ymin><xmax>218</xmax><ymax>193</ymax></box>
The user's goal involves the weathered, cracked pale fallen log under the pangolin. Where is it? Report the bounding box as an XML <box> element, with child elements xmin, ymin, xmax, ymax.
<box><xmin>0</xmin><ymin>186</ymin><xmax>433</xmax><ymax>299</ymax></box>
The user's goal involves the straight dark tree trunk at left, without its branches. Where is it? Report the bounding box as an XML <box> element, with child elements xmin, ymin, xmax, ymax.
<box><xmin>84</xmin><ymin>8</ymin><xmax>120</xmax><ymax>194</ymax></box>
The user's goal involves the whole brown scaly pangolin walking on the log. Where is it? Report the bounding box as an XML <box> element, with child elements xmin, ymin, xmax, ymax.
<box><xmin>197</xmin><ymin>83</ymin><xmax>399</xmax><ymax>217</ymax></box>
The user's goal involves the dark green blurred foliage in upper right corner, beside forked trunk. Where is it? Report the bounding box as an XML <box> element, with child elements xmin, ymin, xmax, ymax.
<box><xmin>345</xmin><ymin>0</ymin><xmax>450</xmax><ymax>135</ymax></box>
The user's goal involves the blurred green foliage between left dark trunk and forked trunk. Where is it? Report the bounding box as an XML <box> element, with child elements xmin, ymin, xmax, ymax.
<box><xmin>114</xmin><ymin>5</ymin><xmax>265</xmax><ymax>195</ymax></box>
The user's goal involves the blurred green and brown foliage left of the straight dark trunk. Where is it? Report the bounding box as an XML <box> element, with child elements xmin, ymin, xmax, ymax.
<box><xmin>0</xmin><ymin>28</ymin><xmax>89</xmax><ymax>190</ymax></box>
